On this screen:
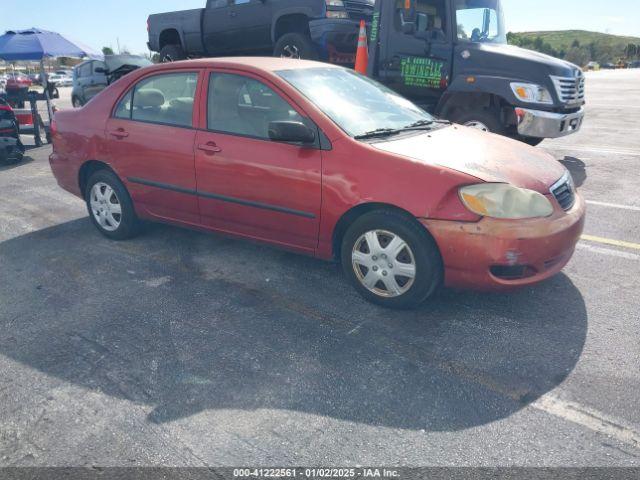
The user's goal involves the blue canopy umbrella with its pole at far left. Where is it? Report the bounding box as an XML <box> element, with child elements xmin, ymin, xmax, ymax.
<box><xmin>0</xmin><ymin>28</ymin><xmax>101</xmax><ymax>121</ymax></box>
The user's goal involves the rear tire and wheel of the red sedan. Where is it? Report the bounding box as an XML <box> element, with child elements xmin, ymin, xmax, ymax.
<box><xmin>85</xmin><ymin>170</ymin><xmax>141</xmax><ymax>240</ymax></box>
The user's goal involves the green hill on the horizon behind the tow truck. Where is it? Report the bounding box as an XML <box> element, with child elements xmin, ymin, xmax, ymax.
<box><xmin>508</xmin><ymin>30</ymin><xmax>640</xmax><ymax>65</ymax></box>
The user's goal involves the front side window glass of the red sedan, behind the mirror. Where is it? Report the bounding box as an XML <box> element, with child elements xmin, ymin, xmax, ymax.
<box><xmin>207</xmin><ymin>73</ymin><xmax>304</xmax><ymax>139</ymax></box>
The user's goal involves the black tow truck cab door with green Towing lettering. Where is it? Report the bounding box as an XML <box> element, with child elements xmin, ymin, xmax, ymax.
<box><xmin>380</xmin><ymin>0</ymin><xmax>453</xmax><ymax>108</ymax></box>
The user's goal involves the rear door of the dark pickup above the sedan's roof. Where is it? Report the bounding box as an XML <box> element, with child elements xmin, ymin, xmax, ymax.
<box><xmin>228</xmin><ymin>0</ymin><xmax>272</xmax><ymax>53</ymax></box>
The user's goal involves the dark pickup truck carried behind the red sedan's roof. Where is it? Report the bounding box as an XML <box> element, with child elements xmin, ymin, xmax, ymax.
<box><xmin>148</xmin><ymin>0</ymin><xmax>374</xmax><ymax>64</ymax></box>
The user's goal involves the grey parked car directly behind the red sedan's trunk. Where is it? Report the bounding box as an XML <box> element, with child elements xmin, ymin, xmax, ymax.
<box><xmin>71</xmin><ymin>55</ymin><xmax>153</xmax><ymax>108</ymax></box>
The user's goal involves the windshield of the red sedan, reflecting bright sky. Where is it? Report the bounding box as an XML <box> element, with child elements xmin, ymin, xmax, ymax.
<box><xmin>276</xmin><ymin>67</ymin><xmax>434</xmax><ymax>137</ymax></box>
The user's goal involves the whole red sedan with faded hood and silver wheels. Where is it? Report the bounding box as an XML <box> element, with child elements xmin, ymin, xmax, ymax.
<box><xmin>50</xmin><ymin>58</ymin><xmax>585</xmax><ymax>308</ymax></box>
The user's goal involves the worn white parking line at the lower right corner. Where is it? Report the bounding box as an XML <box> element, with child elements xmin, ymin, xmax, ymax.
<box><xmin>531</xmin><ymin>394</ymin><xmax>640</xmax><ymax>448</ymax></box>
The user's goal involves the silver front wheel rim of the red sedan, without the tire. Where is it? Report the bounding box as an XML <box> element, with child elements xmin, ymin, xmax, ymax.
<box><xmin>351</xmin><ymin>230</ymin><xmax>416</xmax><ymax>298</ymax></box>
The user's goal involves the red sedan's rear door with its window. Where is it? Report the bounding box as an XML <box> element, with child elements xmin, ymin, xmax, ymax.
<box><xmin>105</xmin><ymin>71</ymin><xmax>200</xmax><ymax>224</ymax></box>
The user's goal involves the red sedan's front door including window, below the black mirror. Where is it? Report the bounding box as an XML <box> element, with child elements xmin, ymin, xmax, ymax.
<box><xmin>196</xmin><ymin>72</ymin><xmax>322</xmax><ymax>253</ymax></box>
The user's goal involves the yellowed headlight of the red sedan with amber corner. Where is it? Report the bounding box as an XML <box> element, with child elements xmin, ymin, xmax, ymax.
<box><xmin>460</xmin><ymin>183</ymin><xmax>553</xmax><ymax>220</ymax></box>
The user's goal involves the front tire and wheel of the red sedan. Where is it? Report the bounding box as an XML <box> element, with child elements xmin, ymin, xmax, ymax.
<box><xmin>341</xmin><ymin>210</ymin><xmax>444</xmax><ymax>309</ymax></box>
